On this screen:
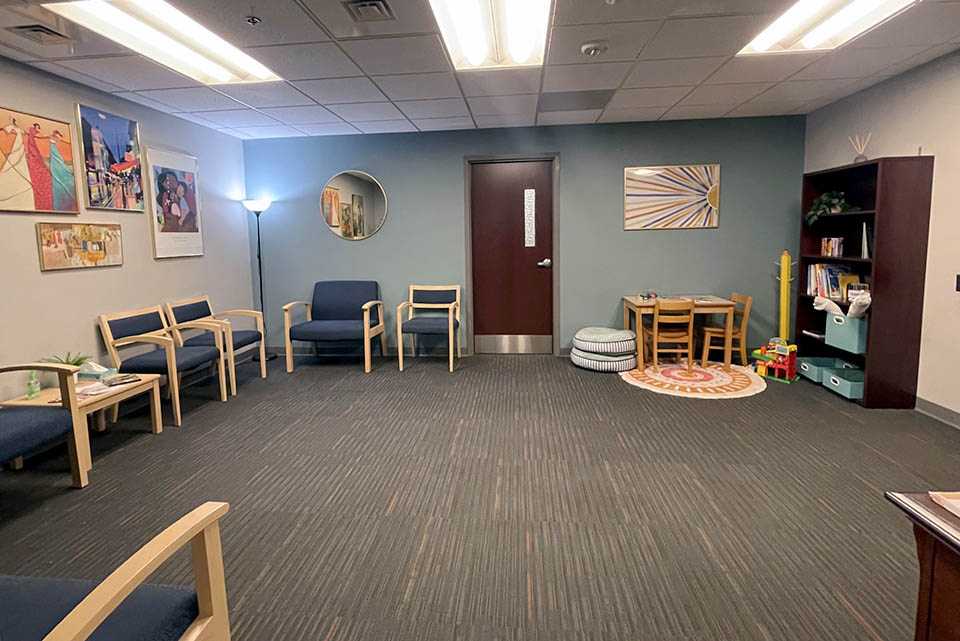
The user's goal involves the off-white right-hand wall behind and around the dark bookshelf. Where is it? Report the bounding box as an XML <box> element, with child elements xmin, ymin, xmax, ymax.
<box><xmin>805</xmin><ymin>47</ymin><xmax>960</xmax><ymax>412</ymax></box>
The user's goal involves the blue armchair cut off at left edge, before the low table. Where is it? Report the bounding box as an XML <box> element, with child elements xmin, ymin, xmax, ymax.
<box><xmin>0</xmin><ymin>363</ymin><xmax>93</xmax><ymax>487</ymax></box>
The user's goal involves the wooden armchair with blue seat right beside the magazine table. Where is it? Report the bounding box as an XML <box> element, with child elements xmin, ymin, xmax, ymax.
<box><xmin>100</xmin><ymin>305</ymin><xmax>227</xmax><ymax>426</ymax></box>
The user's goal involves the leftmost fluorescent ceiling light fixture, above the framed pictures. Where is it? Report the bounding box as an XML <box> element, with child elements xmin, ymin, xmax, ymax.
<box><xmin>42</xmin><ymin>0</ymin><xmax>281</xmax><ymax>85</ymax></box>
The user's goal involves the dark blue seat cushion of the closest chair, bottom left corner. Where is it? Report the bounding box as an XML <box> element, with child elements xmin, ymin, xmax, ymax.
<box><xmin>0</xmin><ymin>575</ymin><xmax>198</xmax><ymax>641</ymax></box>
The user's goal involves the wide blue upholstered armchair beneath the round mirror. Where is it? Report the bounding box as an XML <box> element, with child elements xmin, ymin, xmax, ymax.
<box><xmin>283</xmin><ymin>280</ymin><xmax>387</xmax><ymax>372</ymax></box>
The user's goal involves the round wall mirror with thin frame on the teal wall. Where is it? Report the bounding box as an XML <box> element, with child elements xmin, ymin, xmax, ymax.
<box><xmin>320</xmin><ymin>169</ymin><xmax>387</xmax><ymax>240</ymax></box>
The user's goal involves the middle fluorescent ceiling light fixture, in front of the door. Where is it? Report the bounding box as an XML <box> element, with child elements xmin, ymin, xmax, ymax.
<box><xmin>430</xmin><ymin>0</ymin><xmax>550</xmax><ymax>70</ymax></box>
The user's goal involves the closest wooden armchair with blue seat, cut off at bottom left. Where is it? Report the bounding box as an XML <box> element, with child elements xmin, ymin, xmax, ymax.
<box><xmin>0</xmin><ymin>502</ymin><xmax>230</xmax><ymax>641</ymax></box>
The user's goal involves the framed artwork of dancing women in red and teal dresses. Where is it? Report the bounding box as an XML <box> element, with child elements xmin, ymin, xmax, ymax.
<box><xmin>0</xmin><ymin>107</ymin><xmax>80</xmax><ymax>214</ymax></box>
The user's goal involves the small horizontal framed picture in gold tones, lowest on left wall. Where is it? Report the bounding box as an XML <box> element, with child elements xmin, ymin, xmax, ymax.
<box><xmin>37</xmin><ymin>223</ymin><xmax>123</xmax><ymax>272</ymax></box>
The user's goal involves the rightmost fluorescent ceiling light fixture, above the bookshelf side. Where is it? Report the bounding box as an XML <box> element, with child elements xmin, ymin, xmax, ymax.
<box><xmin>737</xmin><ymin>0</ymin><xmax>922</xmax><ymax>55</ymax></box>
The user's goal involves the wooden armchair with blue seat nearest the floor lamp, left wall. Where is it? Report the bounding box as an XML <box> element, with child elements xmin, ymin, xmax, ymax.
<box><xmin>163</xmin><ymin>294</ymin><xmax>267</xmax><ymax>396</ymax></box>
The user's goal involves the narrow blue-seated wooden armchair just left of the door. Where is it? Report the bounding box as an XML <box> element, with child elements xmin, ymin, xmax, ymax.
<box><xmin>397</xmin><ymin>285</ymin><xmax>460</xmax><ymax>372</ymax></box>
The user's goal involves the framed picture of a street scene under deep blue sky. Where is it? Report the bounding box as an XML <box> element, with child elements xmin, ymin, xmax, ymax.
<box><xmin>77</xmin><ymin>104</ymin><xmax>143</xmax><ymax>212</ymax></box>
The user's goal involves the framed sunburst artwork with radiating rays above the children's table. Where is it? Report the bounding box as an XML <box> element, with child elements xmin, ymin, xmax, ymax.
<box><xmin>623</xmin><ymin>165</ymin><xmax>720</xmax><ymax>231</ymax></box>
